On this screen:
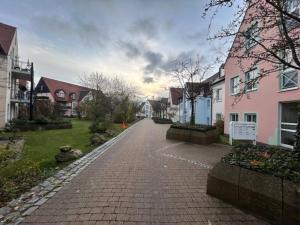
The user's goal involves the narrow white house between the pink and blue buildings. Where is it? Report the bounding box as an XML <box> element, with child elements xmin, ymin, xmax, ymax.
<box><xmin>211</xmin><ymin>65</ymin><xmax>225</xmax><ymax>124</ymax></box>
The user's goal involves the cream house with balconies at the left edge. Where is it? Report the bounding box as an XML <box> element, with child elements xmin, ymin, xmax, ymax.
<box><xmin>0</xmin><ymin>23</ymin><xmax>33</xmax><ymax>128</ymax></box>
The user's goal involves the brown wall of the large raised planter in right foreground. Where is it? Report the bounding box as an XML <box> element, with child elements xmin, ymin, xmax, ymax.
<box><xmin>207</xmin><ymin>162</ymin><xmax>300</xmax><ymax>225</ymax></box>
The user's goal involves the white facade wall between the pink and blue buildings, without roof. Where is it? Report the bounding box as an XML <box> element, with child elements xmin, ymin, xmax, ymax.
<box><xmin>212</xmin><ymin>80</ymin><xmax>225</xmax><ymax>124</ymax></box>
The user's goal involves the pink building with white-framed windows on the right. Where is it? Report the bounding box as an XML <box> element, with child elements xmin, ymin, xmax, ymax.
<box><xmin>224</xmin><ymin>0</ymin><xmax>300</xmax><ymax>148</ymax></box>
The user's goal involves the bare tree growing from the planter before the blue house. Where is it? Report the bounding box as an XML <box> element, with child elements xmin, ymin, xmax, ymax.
<box><xmin>172</xmin><ymin>56</ymin><xmax>212</xmax><ymax>125</ymax></box>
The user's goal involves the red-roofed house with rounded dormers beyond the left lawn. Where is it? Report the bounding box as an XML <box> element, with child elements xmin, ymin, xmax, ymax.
<box><xmin>35</xmin><ymin>77</ymin><xmax>91</xmax><ymax>116</ymax></box>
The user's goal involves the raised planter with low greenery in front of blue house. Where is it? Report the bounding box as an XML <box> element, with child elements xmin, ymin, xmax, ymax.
<box><xmin>166</xmin><ymin>124</ymin><xmax>218</xmax><ymax>145</ymax></box>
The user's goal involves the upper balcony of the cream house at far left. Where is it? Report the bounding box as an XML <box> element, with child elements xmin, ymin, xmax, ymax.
<box><xmin>11</xmin><ymin>59</ymin><xmax>31</xmax><ymax>81</ymax></box>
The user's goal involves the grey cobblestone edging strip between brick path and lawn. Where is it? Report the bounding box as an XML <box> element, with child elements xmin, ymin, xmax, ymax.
<box><xmin>0</xmin><ymin>123</ymin><xmax>137</xmax><ymax>225</ymax></box>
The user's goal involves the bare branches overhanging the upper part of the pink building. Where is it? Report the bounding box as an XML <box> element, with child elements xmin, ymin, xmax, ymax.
<box><xmin>204</xmin><ymin>0</ymin><xmax>300</xmax><ymax>94</ymax></box>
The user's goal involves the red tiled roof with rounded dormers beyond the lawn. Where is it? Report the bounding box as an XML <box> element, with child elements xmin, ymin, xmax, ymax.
<box><xmin>36</xmin><ymin>77</ymin><xmax>91</xmax><ymax>101</ymax></box>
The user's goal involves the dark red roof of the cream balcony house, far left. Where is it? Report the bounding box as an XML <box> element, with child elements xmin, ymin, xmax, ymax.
<box><xmin>0</xmin><ymin>23</ymin><xmax>17</xmax><ymax>55</ymax></box>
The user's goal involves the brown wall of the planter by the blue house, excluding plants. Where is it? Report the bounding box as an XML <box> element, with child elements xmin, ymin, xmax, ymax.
<box><xmin>166</xmin><ymin>127</ymin><xmax>218</xmax><ymax>145</ymax></box>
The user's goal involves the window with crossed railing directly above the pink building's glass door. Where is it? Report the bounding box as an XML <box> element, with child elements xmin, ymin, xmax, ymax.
<box><xmin>280</xmin><ymin>50</ymin><xmax>298</xmax><ymax>90</ymax></box>
